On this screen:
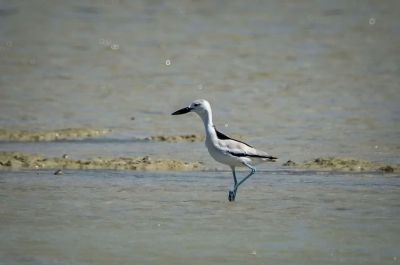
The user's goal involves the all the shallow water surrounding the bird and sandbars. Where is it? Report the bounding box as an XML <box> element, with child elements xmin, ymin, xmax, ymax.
<box><xmin>0</xmin><ymin>0</ymin><xmax>400</xmax><ymax>265</ymax></box>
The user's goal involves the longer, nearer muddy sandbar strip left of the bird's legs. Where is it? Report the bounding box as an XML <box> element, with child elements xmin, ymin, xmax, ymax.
<box><xmin>0</xmin><ymin>152</ymin><xmax>203</xmax><ymax>171</ymax></box>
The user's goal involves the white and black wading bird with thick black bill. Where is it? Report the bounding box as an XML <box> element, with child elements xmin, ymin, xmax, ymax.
<box><xmin>172</xmin><ymin>99</ymin><xmax>277</xmax><ymax>201</ymax></box>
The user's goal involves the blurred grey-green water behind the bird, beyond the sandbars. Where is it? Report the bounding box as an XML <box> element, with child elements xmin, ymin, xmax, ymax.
<box><xmin>0</xmin><ymin>0</ymin><xmax>400</xmax><ymax>163</ymax></box>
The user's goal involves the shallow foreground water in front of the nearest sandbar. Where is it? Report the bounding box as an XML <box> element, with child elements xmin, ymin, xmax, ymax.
<box><xmin>0</xmin><ymin>171</ymin><xmax>400</xmax><ymax>264</ymax></box>
